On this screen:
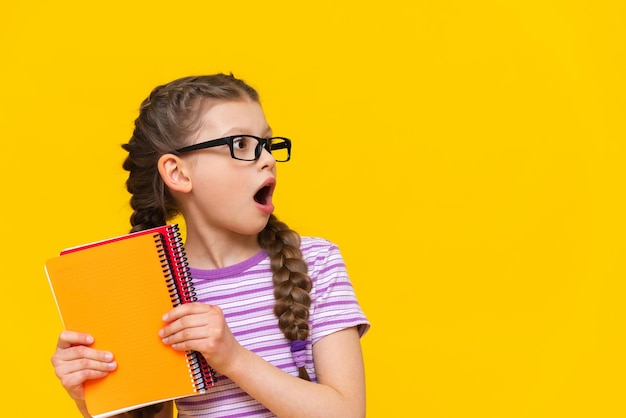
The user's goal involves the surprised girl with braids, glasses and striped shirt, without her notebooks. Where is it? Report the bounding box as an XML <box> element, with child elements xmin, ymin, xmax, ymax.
<box><xmin>52</xmin><ymin>74</ymin><xmax>369</xmax><ymax>418</ymax></box>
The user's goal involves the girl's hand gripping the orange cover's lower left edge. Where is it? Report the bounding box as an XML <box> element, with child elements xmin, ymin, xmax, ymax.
<box><xmin>52</xmin><ymin>331</ymin><xmax>117</xmax><ymax>401</ymax></box>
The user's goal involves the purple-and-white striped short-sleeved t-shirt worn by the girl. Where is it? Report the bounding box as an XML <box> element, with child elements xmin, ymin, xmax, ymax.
<box><xmin>176</xmin><ymin>237</ymin><xmax>370</xmax><ymax>418</ymax></box>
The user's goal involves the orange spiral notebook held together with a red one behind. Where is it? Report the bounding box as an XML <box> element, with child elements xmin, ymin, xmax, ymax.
<box><xmin>45</xmin><ymin>224</ymin><xmax>215</xmax><ymax>418</ymax></box>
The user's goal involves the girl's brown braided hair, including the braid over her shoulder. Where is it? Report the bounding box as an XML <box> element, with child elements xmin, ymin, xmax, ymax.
<box><xmin>122</xmin><ymin>74</ymin><xmax>311</xmax><ymax>380</ymax></box>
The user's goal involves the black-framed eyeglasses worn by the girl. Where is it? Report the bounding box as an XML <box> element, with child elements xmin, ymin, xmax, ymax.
<box><xmin>174</xmin><ymin>135</ymin><xmax>291</xmax><ymax>162</ymax></box>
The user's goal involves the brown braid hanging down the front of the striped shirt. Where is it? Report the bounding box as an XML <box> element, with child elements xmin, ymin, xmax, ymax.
<box><xmin>259</xmin><ymin>215</ymin><xmax>311</xmax><ymax>380</ymax></box>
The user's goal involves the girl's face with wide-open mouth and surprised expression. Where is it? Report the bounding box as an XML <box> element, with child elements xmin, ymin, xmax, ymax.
<box><xmin>182</xmin><ymin>100</ymin><xmax>276</xmax><ymax>240</ymax></box>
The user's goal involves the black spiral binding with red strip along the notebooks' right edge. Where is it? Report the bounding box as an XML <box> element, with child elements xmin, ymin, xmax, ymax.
<box><xmin>154</xmin><ymin>224</ymin><xmax>215</xmax><ymax>393</ymax></box>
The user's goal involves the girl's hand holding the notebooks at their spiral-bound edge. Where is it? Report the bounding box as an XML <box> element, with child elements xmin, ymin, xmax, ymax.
<box><xmin>159</xmin><ymin>302</ymin><xmax>241</xmax><ymax>374</ymax></box>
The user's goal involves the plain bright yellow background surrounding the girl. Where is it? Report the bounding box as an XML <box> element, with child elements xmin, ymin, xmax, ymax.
<box><xmin>0</xmin><ymin>0</ymin><xmax>626</xmax><ymax>418</ymax></box>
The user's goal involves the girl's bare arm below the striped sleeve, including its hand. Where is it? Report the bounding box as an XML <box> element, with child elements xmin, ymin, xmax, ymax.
<box><xmin>160</xmin><ymin>303</ymin><xmax>365</xmax><ymax>418</ymax></box>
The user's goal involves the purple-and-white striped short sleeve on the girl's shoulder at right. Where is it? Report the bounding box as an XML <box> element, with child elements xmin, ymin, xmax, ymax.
<box><xmin>303</xmin><ymin>238</ymin><xmax>370</xmax><ymax>344</ymax></box>
